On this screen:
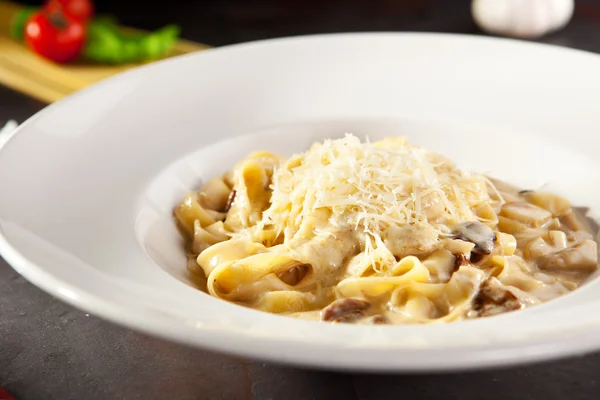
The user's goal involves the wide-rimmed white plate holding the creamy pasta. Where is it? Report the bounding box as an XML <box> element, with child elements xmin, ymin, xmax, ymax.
<box><xmin>0</xmin><ymin>34</ymin><xmax>600</xmax><ymax>371</ymax></box>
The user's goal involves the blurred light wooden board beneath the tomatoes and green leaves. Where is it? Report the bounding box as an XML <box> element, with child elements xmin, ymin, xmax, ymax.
<box><xmin>0</xmin><ymin>1</ymin><xmax>208</xmax><ymax>103</ymax></box>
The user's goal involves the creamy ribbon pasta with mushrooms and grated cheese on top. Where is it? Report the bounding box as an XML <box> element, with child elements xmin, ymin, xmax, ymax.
<box><xmin>175</xmin><ymin>135</ymin><xmax>598</xmax><ymax>324</ymax></box>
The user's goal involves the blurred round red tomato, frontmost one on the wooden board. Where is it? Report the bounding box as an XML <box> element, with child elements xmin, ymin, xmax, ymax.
<box><xmin>25</xmin><ymin>11</ymin><xmax>85</xmax><ymax>63</ymax></box>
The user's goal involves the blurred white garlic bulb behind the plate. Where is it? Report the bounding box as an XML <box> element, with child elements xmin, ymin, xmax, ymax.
<box><xmin>471</xmin><ymin>0</ymin><xmax>574</xmax><ymax>39</ymax></box>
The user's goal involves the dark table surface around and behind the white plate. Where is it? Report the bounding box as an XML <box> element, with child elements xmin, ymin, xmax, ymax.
<box><xmin>0</xmin><ymin>0</ymin><xmax>600</xmax><ymax>400</ymax></box>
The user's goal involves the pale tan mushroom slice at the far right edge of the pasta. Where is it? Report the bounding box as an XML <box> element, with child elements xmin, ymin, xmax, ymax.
<box><xmin>536</xmin><ymin>240</ymin><xmax>598</xmax><ymax>272</ymax></box>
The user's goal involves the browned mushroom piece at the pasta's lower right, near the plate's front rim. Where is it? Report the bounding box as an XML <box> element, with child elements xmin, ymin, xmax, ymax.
<box><xmin>473</xmin><ymin>277</ymin><xmax>525</xmax><ymax>317</ymax></box>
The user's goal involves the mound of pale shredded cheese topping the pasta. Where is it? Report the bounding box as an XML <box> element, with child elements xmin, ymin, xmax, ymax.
<box><xmin>259</xmin><ymin>134</ymin><xmax>491</xmax><ymax>245</ymax></box>
